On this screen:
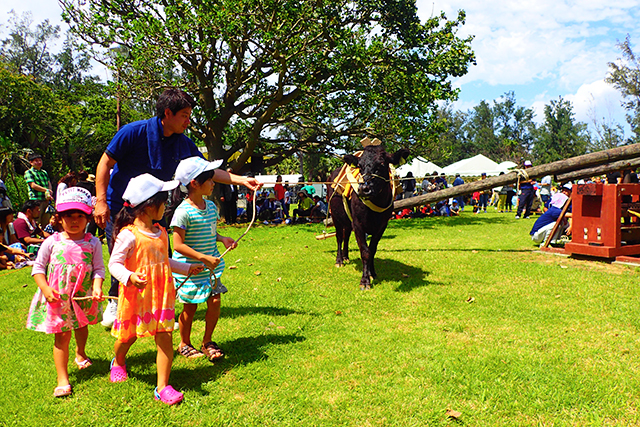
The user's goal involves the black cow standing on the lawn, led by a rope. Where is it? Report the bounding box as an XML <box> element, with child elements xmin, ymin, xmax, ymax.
<box><xmin>328</xmin><ymin>145</ymin><xmax>409</xmax><ymax>289</ymax></box>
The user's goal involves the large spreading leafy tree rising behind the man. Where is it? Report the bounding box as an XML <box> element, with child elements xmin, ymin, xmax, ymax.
<box><xmin>61</xmin><ymin>0</ymin><xmax>474</xmax><ymax>169</ymax></box>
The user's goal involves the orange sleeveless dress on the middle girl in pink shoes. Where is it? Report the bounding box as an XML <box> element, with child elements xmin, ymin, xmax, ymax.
<box><xmin>111</xmin><ymin>225</ymin><xmax>176</xmax><ymax>342</ymax></box>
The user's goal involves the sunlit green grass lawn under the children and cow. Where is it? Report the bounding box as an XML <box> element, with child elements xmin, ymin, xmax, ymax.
<box><xmin>0</xmin><ymin>212</ymin><xmax>640</xmax><ymax>427</ymax></box>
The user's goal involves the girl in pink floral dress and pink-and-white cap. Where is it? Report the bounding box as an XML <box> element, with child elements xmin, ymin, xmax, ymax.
<box><xmin>27</xmin><ymin>187</ymin><xmax>105</xmax><ymax>397</ymax></box>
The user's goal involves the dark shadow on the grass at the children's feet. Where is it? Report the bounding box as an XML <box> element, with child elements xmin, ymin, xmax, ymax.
<box><xmin>122</xmin><ymin>334</ymin><xmax>306</xmax><ymax>396</ymax></box>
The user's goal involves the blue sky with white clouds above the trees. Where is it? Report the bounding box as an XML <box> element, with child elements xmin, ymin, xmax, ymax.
<box><xmin>0</xmin><ymin>0</ymin><xmax>640</xmax><ymax>136</ymax></box>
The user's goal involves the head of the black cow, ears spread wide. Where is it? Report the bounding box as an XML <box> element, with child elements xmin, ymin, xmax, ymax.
<box><xmin>343</xmin><ymin>145</ymin><xmax>410</xmax><ymax>199</ymax></box>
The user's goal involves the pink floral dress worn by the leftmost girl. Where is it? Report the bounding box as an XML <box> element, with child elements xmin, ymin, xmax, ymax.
<box><xmin>27</xmin><ymin>233</ymin><xmax>102</xmax><ymax>334</ymax></box>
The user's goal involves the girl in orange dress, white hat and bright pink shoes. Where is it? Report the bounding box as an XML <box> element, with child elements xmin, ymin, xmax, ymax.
<box><xmin>109</xmin><ymin>174</ymin><xmax>204</xmax><ymax>405</ymax></box>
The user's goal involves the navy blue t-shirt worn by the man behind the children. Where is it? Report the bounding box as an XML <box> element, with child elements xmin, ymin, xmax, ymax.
<box><xmin>105</xmin><ymin>117</ymin><xmax>203</xmax><ymax>218</ymax></box>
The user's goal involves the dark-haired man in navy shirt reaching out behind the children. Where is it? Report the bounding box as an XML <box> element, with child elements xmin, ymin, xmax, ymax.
<box><xmin>94</xmin><ymin>88</ymin><xmax>261</xmax><ymax>327</ymax></box>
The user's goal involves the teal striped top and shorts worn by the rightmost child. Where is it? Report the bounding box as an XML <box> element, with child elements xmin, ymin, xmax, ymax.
<box><xmin>171</xmin><ymin>199</ymin><xmax>226</xmax><ymax>304</ymax></box>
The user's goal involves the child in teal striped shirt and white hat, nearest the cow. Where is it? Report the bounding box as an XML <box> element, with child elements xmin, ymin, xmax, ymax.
<box><xmin>171</xmin><ymin>157</ymin><xmax>236</xmax><ymax>362</ymax></box>
